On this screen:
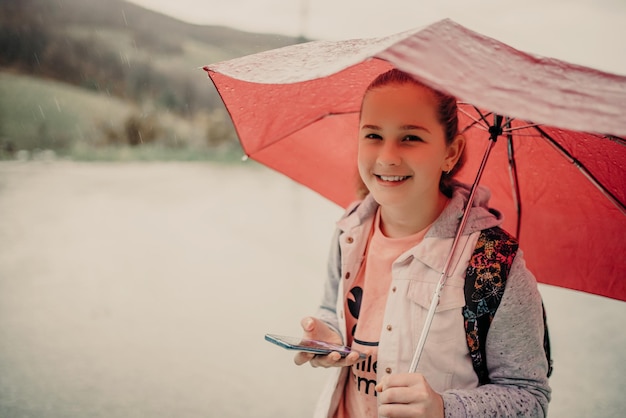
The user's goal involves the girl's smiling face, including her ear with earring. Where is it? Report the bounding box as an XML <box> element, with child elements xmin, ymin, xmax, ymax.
<box><xmin>358</xmin><ymin>83</ymin><xmax>463</xmax><ymax>208</ymax></box>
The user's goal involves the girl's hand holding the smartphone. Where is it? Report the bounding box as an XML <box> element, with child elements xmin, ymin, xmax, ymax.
<box><xmin>293</xmin><ymin>317</ymin><xmax>359</xmax><ymax>367</ymax></box>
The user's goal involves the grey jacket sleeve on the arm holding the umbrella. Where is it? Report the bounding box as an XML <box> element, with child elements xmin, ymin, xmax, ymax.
<box><xmin>442</xmin><ymin>251</ymin><xmax>550</xmax><ymax>418</ymax></box>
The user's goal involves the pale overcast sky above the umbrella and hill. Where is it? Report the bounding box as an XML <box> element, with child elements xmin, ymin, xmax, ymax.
<box><xmin>128</xmin><ymin>0</ymin><xmax>626</xmax><ymax>75</ymax></box>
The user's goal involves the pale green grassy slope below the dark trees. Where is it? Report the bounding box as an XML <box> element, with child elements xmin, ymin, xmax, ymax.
<box><xmin>0</xmin><ymin>72</ymin><xmax>242</xmax><ymax>161</ymax></box>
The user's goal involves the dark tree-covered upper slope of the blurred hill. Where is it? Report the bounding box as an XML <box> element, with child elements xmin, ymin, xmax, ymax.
<box><xmin>0</xmin><ymin>0</ymin><xmax>298</xmax><ymax>116</ymax></box>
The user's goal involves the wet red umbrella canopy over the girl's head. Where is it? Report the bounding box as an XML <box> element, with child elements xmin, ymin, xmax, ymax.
<box><xmin>205</xmin><ymin>20</ymin><xmax>626</xmax><ymax>300</ymax></box>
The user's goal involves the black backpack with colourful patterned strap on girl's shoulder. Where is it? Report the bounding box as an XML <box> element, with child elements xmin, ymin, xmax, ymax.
<box><xmin>463</xmin><ymin>227</ymin><xmax>552</xmax><ymax>385</ymax></box>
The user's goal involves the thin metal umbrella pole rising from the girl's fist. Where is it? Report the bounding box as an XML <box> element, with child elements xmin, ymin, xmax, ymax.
<box><xmin>409</xmin><ymin>115</ymin><xmax>503</xmax><ymax>373</ymax></box>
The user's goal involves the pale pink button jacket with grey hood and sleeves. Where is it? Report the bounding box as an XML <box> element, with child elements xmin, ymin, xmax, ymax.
<box><xmin>315</xmin><ymin>184</ymin><xmax>550</xmax><ymax>418</ymax></box>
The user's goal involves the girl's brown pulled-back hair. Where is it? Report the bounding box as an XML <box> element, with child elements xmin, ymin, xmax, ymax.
<box><xmin>358</xmin><ymin>68</ymin><xmax>465</xmax><ymax>198</ymax></box>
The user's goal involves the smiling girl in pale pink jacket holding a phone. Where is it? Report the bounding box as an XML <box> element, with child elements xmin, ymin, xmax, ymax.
<box><xmin>295</xmin><ymin>69</ymin><xmax>550</xmax><ymax>418</ymax></box>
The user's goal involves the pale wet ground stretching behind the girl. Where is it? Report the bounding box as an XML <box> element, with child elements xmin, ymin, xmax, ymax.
<box><xmin>0</xmin><ymin>162</ymin><xmax>626</xmax><ymax>418</ymax></box>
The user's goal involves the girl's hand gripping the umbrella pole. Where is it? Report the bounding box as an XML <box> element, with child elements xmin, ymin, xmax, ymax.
<box><xmin>376</xmin><ymin>373</ymin><xmax>444</xmax><ymax>418</ymax></box>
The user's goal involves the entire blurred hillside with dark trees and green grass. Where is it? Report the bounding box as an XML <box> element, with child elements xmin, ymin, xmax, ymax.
<box><xmin>0</xmin><ymin>0</ymin><xmax>299</xmax><ymax>159</ymax></box>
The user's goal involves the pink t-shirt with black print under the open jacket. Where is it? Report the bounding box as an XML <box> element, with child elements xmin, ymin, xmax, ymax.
<box><xmin>335</xmin><ymin>208</ymin><xmax>428</xmax><ymax>418</ymax></box>
